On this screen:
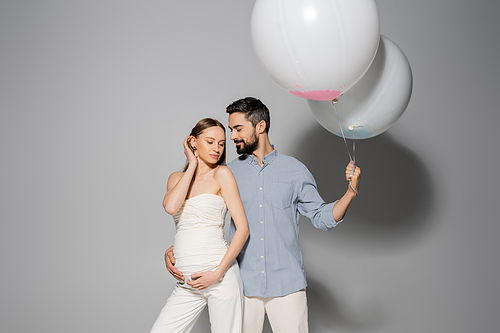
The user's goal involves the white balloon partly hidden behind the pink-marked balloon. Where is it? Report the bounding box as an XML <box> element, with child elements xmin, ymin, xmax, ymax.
<box><xmin>308</xmin><ymin>36</ymin><xmax>413</xmax><ymax>139</ymax></box>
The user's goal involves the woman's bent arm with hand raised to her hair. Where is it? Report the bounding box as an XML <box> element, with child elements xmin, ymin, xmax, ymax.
<box><xmin>163</xmin><ymin>136</ymin><xmax>198</xmax><ymax>215</ymax></box>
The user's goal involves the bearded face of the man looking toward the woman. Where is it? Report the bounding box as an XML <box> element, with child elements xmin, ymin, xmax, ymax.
<box><xmin>229</xmin><ymin>112</ymin><xmax>259</xmax><ymax>155</ymax></box>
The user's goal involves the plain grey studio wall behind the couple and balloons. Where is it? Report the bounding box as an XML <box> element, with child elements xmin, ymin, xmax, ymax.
<box><xmin>0</xmin><ymin>0</ymin><xmax>500</xmax><ymax>333</ymax></box>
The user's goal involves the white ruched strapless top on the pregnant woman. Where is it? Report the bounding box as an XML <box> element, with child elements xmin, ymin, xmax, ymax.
<box><xmin>174</xmin><ymin>193</ymin><xmax>228</xmax><ymax>276</ymax></box>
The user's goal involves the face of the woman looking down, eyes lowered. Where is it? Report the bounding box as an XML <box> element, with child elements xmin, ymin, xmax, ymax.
<box><xmin>191</xmin><ymin>126</ymin><xmax>226</xmax><ymax>164</ymax></box>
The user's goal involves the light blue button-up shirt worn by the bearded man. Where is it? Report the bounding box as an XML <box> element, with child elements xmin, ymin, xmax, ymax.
<box><xmin>227</xmin><ymin>149</ymin><xmax>341</xmax><ymax>297</ymax></box>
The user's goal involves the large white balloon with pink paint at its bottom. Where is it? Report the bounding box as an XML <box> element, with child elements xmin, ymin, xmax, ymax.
<box><xmin>251</xmin><ymin>0</ymin><xmax>380</xmax><ymax>101</ymax></box>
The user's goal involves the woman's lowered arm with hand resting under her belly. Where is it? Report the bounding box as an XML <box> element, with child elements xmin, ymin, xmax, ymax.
<box><xmin>187</xmin><ymin>166</ymin><xmax>248</xmax><ymax>290</ymax></box>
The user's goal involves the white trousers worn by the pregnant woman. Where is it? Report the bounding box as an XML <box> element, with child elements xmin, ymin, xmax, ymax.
<box><xmin>151</xmin><ymin>261</ymin><xmax>243</xmax><ymax>333</ymax></box>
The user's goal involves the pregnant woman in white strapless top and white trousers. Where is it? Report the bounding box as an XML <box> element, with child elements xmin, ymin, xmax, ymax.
<box><xmin>151</xmin><ymin>118</ymin><xmax>248</xmax><ymax>333</ymax></box>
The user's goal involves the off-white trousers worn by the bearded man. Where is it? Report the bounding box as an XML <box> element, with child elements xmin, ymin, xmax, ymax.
<box><xmin>243</xmin><ymin>288</ymin><xmax>309</xmax><ymax>333</ymax></box>
